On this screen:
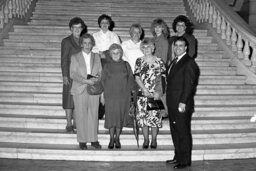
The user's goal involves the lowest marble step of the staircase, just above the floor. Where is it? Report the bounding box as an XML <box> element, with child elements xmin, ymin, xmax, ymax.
<box><xmin>0</xmin><ymin>143</ymin><xmax>256</xmax><ymax>162</ymax></box>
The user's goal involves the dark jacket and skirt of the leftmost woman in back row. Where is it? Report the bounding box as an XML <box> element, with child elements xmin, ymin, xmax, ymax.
<box><xmin>61</xmin><ymin>35</ymin><xmax>81</xmax><ymax>109</ymax></box>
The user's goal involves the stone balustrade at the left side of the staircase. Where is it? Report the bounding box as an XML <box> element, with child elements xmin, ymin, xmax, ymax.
<box><xmin>0</xmin><ymin>0</ymin><xmax>33</xmax><ymax>29</ymax></box>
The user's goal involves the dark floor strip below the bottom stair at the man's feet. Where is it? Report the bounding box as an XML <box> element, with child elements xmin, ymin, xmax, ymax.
<box><xmin>0</xmin><ymin>158</ymin><xmax>256</xmax><ymax>171</ymax></box>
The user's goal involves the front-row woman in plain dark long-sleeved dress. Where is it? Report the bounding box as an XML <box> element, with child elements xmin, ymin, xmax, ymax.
<box><xmin>102</xmin><ymin>44</ymin><xmax>135</xmax><ymax>149</ymax></box>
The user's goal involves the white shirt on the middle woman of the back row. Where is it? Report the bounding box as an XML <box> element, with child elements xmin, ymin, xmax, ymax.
<box><xmin>122</xmin><ymin>39</ymin><xmax>144</xmax><ymax>72</ymax></box>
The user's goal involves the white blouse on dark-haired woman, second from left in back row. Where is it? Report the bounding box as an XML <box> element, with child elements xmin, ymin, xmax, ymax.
<box><xmin>92</xmin><ymin>30</ymin><xmax>120</xmax><ymax>53</ymax></box>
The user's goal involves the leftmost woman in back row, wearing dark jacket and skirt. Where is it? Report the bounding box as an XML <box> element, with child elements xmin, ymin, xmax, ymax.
<box><xmin>61</xmin><ymin>17</ymin><xmax>87</xmax><ymax>133</ymax></box>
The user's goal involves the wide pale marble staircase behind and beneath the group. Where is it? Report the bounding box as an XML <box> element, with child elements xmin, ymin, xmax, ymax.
<box><xmin>0</xmin><ymin>0</ymin><xmax>256</xmax><ymax>161</ymax></box>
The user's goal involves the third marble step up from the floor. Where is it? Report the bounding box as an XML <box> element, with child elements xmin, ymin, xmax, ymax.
<box><xmin>0</xmin><ymin>117</ymin><xmax>256</xmax><ymax>131</ymax></box>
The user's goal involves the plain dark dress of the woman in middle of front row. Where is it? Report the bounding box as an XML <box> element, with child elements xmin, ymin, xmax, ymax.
<box><xmin>102</xmin><ymin>60</ymin><xmax>135</xmax><ymax>129</ymax></box>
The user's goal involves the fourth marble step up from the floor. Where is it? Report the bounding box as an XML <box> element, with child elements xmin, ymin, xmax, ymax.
<box><xmin>0</xmin><ymin>102</ymin><xmax>256</xmax><ymax>119</ymax></box>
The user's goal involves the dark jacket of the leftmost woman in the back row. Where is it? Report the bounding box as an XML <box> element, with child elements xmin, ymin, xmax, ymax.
<box><xmin>61</xmin><ymin>35</ymin><xmax>81</xmax><ymax>78</ymax></box>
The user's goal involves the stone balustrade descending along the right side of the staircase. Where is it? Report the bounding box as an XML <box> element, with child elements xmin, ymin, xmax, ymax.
<box><xmin>187</xmin><ymin>0</ymin><xmax>256</xmax><ymax>73</ymax></box>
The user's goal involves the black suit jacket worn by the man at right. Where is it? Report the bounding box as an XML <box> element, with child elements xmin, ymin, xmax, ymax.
<box><xmin>166</xmin><ymin>54</ymin><xmax>199</xmax><ymax>110</ymax></box>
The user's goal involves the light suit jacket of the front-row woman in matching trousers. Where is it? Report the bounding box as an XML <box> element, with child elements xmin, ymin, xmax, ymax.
<box><xmin>70</xmin><ymin>51</ymin><xmax>102</xmax><ymax>95</ymax></box>
